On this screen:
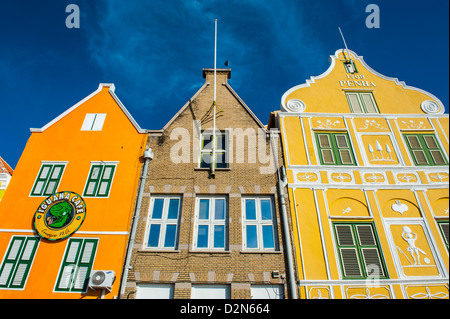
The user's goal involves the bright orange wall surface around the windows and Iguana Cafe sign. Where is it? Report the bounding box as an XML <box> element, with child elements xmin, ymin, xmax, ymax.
<box><xmin>0</xmin><ymin>85</ymin><xmax>147</xmax><ymax>298</ymax></box>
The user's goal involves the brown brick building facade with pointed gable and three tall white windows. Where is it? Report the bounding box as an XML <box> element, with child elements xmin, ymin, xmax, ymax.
<box><xmin>121</xmin><ymin>69</ymin><xmax>295</xmax><ymax>298</ymax></box>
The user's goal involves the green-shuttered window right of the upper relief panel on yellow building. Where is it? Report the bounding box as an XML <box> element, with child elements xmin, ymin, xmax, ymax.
<box><xmin>404</xmin><ymin>134</ymin><xmax>448</xmax><ymax>166</ymax></box>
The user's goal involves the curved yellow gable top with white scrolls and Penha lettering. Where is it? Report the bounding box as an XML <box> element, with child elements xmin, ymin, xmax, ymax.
<box><xmin>281</xmin><ymin>49</ymin><xmax>445</xmax><ymax>114</ymax></box>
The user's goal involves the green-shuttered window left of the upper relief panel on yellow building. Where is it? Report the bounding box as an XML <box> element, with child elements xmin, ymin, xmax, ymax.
<box><xmin>316</xmin><ymin>133</ymin><xmax>356</xmax><ymax>165</ymax></box>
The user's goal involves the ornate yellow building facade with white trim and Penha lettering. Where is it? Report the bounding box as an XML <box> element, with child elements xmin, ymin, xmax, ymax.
<box><xmin>271</xmin><ymin>50</ymin><xmax>449</xmax><ymax>299</ymax></box>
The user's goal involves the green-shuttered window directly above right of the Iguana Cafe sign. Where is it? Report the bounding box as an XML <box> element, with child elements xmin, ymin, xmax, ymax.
<box><xmin>83</xmin><ymin>163</ymin><xmax>116</xmax><ymax>197</ymax></box>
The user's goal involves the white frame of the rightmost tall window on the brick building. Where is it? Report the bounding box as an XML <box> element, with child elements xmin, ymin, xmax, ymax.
<box><xmin>241</xmin><ymin>196</ymin><xmax>280</xmax><ymax>252</ymax></box>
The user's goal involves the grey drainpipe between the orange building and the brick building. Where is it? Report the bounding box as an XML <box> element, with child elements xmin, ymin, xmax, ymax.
<box><xmin>119</xmin><ymin>148</ymin><xmax>153</xmax><ymax>298</ymax></box>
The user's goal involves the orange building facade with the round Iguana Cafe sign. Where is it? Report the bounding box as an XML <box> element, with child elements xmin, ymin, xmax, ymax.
<box><xmin>0</xmin><ymin>84</ymin><xmax>147</xmax><ymax>299</ymax></box>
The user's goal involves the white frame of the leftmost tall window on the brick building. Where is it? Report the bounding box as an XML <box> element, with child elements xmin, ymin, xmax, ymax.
<box><xmin>143</xmin><ymin>195</ymin><xmax>183</xmax><ymax>250</ymax></box>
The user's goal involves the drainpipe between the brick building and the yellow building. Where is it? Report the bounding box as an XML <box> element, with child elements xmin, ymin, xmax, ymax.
<box><xmin>270</xmin><ymin>131</ymin><xmax>297</xmax><ymax>299</ymax></box>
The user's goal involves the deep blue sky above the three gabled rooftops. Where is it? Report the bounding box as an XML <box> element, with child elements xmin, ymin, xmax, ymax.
<box><xmin>0</xmin><ymin>0</ymin><xmax>449</xmax><ymax>167</ymax></box>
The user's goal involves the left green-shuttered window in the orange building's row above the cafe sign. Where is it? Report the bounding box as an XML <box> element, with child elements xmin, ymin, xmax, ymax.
<box><xmin>31</xmin><ymin>163</ymin><xmax>65</xmax><ymax>196</ymax></box>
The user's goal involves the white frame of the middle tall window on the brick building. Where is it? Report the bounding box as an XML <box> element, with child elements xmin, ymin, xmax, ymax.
<box><xmin>193</xmin><ymin>196</ymin><xmax>229</xmax><ymax>251</ymax></box>
